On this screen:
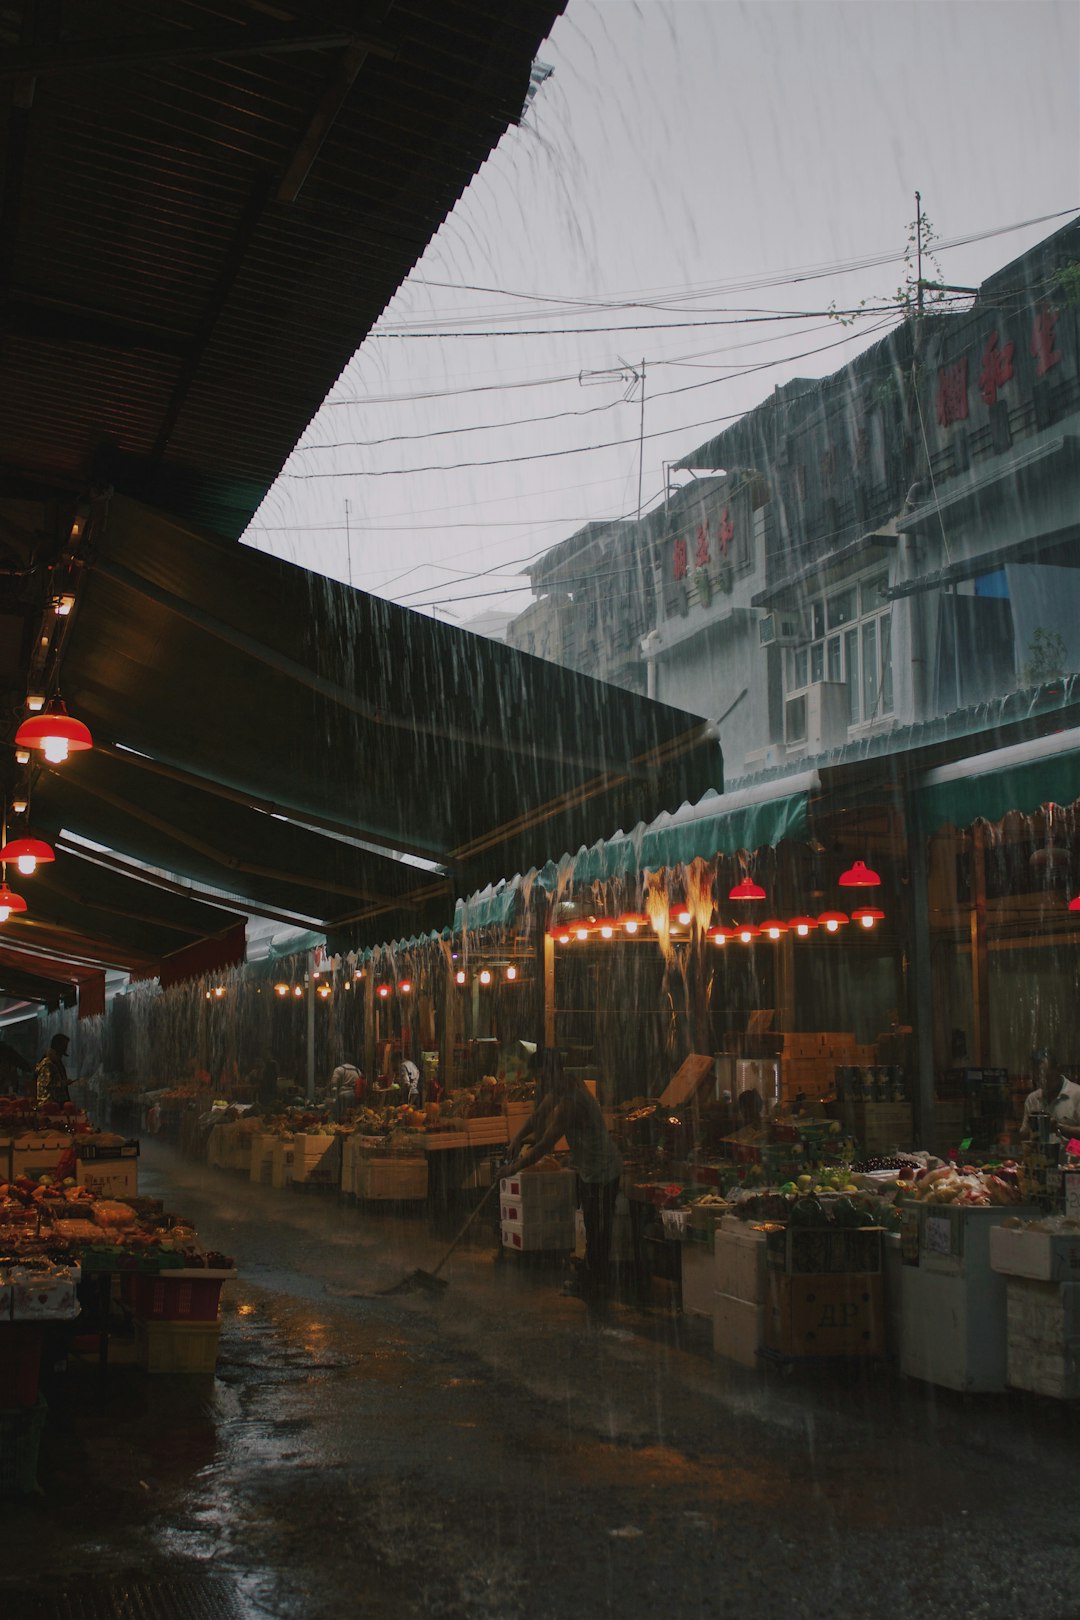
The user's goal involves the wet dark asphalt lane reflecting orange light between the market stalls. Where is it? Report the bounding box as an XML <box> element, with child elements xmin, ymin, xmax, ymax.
<box><xmin>0</xmin><ymin>1144</ymin><xmax>1080</xmax><ymax>1620</ymax></box>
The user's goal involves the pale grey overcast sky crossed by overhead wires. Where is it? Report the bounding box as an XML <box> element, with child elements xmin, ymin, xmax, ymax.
<box><xmin>246</xmin><ymin>0</ymin><xmax>1080</xmax><ymax>624</ymax></box>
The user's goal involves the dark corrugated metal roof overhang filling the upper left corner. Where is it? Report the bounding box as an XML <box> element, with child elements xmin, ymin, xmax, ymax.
<box><xmin>0</xmin><ymin>0</ymin><xmax>562</xmax><ymax>535</ymax></box>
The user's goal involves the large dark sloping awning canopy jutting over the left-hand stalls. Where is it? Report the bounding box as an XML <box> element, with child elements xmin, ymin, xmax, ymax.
<box><xmin>34</xmin><ymin>496</ymin><xmax>722</xmax><ymax>944</ymax></box>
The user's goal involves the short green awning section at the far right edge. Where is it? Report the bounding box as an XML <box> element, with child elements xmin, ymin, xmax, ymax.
<box><xmin>918</xmin><ymin>731</ymin><xmax>1080</xmax><ymax>833</ymax></box>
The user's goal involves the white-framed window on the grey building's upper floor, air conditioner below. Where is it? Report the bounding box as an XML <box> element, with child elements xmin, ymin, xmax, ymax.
<box><xmin>787</xmin><ymin>572</ymin><xmax>892</xmax><ymax>726</ymax></box>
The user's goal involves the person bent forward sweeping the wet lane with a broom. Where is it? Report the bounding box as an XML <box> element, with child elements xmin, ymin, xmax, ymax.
<box><xmin>502</xmin><ymin>1051</ymin><xmax>622</xmax><ymax>1299</ymax></box>
